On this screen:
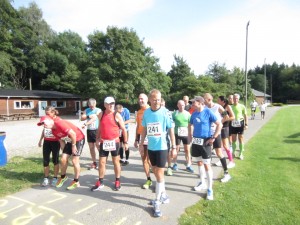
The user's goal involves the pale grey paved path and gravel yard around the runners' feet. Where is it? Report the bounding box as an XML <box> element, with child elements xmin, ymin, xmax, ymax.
<box><xmin>0</xmin><ymin>107</ymin><xmax>279</xmax><ymax>225</ymax></box>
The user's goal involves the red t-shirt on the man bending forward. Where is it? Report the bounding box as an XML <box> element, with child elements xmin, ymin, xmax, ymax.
<box><xmin>52</xmin><ymin>120</ymin><xmax>85</xmax><ymax>141</ymax></box>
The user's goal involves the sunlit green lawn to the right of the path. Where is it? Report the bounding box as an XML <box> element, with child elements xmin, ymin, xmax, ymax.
<box><xmin>179</xmin><ymin>107</ymin><xmax>300</xmax><ymax>225</ymax></box>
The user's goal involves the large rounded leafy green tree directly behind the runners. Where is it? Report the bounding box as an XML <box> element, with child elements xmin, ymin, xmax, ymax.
<box><xmin>80</xmin><ymin>27</ymin><xmax>169</xmax><ymax>104</ymax></box>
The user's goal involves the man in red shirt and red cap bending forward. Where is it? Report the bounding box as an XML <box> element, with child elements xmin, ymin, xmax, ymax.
<box><xmin>37</xmin><ymin>116</ymin><xmax>85</xmax><ymax>190</ymax></box>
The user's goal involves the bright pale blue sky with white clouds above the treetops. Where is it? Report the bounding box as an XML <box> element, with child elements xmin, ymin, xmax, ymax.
<box><xmin>12</xmin><ymin>0</ymin><xmax>300</xmax><ymax>75</ymax></box>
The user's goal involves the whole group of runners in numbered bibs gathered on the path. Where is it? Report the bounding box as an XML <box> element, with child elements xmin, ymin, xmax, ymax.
<box><xmin>38</xmin><ymin>89</ymin><xmax>248</xmax><ymax>217</ymax></box>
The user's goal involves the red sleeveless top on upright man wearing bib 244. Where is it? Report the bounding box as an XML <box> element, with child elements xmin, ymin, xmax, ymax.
<box><xmin>100</xmin><ymin>112</ymin><xmax>120</xmax><ymax>142</ymax></box>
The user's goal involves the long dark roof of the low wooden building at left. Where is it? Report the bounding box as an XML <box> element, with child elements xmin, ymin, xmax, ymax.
<box><xmin>0</xmin><ymin>89</ymin><xmax>80</xmax><ymax>99</ymax></box>
